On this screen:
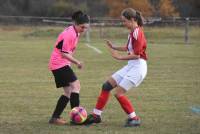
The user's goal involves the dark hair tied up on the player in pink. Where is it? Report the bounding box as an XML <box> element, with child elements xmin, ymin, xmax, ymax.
<box><xmin>72</xmin><ymin>10</ymin><xmax>89</xmax><ymax>25</ymax></box>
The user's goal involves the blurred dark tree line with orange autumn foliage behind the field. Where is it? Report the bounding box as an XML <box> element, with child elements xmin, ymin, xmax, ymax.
<box><xmin>0</xmin><ymin>0</ymin><xmax>200</xmax><ymax>17</ymax></box>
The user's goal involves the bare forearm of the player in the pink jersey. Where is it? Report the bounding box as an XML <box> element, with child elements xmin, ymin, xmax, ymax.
<box><xmin>61</xmin><ymin>52</ymin><xmax>83</xmax><ymax>69</ymax></box>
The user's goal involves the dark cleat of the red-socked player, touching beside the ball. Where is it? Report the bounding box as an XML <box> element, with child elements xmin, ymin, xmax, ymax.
<box><xmin>84</xmin><ymin>114</ymin><xmax>101</xmax><ymax>125</ymax></box>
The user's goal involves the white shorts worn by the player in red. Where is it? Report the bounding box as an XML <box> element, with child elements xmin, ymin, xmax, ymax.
<box><xmin>112</xmin><ymin>59</ymin><xmax>147</xmax><ymax>91</ymax></box>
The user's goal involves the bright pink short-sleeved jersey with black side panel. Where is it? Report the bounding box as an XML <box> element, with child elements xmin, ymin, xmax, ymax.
<box><xmin>49</xmin><ymin>26</ymin><xmax>79</xmax><ymax>70</ymax></box>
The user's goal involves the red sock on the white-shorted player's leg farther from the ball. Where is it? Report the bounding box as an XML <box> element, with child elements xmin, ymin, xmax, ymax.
<box><xmin>116</xmin><ymin>95</ymin><xmax>135</xmax><ymax>114</ymax></box>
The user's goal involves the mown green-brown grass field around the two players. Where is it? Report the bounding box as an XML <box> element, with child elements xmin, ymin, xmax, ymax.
<box><xmin>0</xmin><ymin>26</ymin><xmax>200</xmax><ymax>134</ymax></box>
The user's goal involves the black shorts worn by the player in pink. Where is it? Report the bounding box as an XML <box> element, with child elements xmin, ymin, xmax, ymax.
<box><xmin>52</xmin><ymin>65</ymin><xmax>77</xmax><ymax>88</ymax></box>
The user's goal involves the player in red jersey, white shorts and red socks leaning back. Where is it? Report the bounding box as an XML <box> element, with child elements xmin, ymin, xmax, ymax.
<box><xmin>86</xmin><ymin>8</ymin><xmax>147</xmax><ymax>126</ymax></box>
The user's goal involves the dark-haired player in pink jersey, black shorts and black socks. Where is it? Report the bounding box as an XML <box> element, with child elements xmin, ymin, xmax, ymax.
<box><xmin>49</xmin><ymin>11</ymin><xmax>89</xmax><ymax>125</ymax></box>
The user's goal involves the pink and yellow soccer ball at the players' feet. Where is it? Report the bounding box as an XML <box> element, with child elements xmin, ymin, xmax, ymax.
<box><xmin>70</xmin><ymin>106</ymin><xmax>87</xmax><ymax>124</ymax></box>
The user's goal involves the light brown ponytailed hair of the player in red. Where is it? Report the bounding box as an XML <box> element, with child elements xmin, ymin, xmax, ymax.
<box><xmin>121</xmin><ymin>8</ymin><xmax>143</xmax><ymax>27</ymax></box>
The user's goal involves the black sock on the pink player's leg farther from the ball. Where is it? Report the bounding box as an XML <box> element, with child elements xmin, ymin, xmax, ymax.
<box><xmin>52</xmin><ymin>95</ymin><xmax>69</xmax><ymax>118</ymax></box>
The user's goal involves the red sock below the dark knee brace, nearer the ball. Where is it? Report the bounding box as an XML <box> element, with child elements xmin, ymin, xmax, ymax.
<box><xmin>95</xmin><ymin>90</ymin><xmax>110</xmax><ymax>110</ymax></box>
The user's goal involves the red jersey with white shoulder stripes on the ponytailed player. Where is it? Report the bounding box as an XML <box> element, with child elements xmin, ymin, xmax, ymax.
<box><xmin>127</xmin><ymin>27</ymin><xmax>147</xmax><ymax>60</ymax></box>
